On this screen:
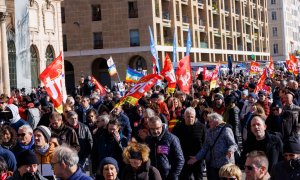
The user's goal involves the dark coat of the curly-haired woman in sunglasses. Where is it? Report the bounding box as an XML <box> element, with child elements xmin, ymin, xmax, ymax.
<box><xmin>121</xmin><ymin>161</ymin><xmax>162</xmax><ymax>180</ymax></box>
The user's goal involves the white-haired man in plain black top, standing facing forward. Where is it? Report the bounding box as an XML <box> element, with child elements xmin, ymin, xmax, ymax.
<box><xmin>172</xmin><ymin>107</ymin><xmax>205</xmax><ymax>180</ymax></box>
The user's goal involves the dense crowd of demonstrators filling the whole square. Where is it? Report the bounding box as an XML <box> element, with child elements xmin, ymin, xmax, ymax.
<box><xmin>0</xmin><ymin>69</ymin><xmax>300</xmax><ymax>180</ymax></box>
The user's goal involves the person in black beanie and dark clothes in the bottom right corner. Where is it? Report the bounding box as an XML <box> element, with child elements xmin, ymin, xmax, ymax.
<box><xmin>271</xmin><ymin>134</ymin><xmax>300</xmax><ymax>180</ymax></box>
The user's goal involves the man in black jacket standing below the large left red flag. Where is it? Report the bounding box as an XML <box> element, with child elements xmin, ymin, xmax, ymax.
<box><xmin>67</xmin><ymin>111</ymin><xmax>93</xmax><ymax>167</ymax></box>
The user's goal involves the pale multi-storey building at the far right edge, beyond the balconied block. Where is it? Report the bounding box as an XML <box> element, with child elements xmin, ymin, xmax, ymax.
<box><xmin>268</xmin><ymin>0</ymin><xmax>300</xmax><ymax>61</ymax></box>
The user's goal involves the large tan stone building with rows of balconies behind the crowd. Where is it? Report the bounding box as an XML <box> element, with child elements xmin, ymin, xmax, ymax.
<box><xmin>62</xmin><ymin>0</ymin><xmax>270</xmax><ymax>90</ymax></box>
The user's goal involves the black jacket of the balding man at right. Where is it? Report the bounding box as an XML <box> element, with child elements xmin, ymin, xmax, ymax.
<box><xmin>241</xmin><ymin>131</ymin><xmax>283</xmax><ymax>172</ymax></box>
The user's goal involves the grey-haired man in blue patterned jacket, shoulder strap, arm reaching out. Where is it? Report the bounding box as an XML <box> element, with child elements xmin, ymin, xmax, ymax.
<box><xmin>187</xmin><ymin>113</ymin><xmax>238</xmax><ymax>179</ymax></box>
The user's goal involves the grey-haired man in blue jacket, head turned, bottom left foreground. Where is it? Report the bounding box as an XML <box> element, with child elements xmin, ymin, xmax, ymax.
<box><xmin>51</xmin><ymin>145</ymin><xmax>92</xmax><ymax>180</ymax></box>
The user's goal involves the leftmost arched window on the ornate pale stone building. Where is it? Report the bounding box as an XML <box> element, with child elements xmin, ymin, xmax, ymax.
<box><xmin>7</xmin><ymin>40</ymin><xmax>17</xmax><ymax>88</ymax></box>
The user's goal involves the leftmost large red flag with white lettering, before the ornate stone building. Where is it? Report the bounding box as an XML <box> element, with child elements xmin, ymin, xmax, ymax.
<box><xmin>39</xmin><ymin>53</ymin><xmax>63</xmax><ymax>113</ymax></box>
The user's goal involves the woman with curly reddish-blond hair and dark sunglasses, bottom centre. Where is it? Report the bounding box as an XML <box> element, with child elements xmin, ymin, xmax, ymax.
<box><xmin>121</xmin><ymin>142</ymin><xmax>161</xmax><ymax>180</ymax></box>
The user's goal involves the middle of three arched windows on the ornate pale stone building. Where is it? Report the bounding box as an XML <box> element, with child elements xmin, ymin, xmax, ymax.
<box><xmin>30</xmin><ymin>45</ymin><xmax>40</xmax><ymax>87</ymax></box>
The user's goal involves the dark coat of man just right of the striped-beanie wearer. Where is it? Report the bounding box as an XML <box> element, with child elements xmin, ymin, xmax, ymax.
<box><xmin>50</xmin><ymin>124</ymin><xmax>80</xmax><ymax>152</ymax></box>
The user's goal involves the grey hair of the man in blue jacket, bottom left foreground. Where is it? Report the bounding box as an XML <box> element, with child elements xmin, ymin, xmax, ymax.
<box><xmin>53</xmin><ymin>144</ymin><xmax>79</xmax><ymax>167</ymax></box>
